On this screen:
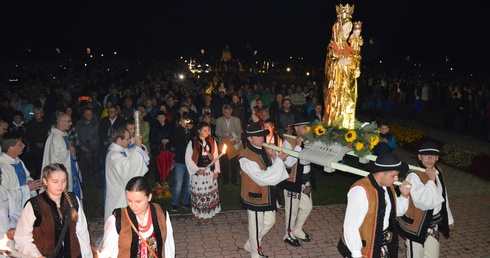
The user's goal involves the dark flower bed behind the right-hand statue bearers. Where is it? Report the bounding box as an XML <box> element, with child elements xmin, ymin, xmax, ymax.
<box><xmin>389</xmin><ymin>124</ymin><xmax>490</xmax><ymax>179</ymax></box>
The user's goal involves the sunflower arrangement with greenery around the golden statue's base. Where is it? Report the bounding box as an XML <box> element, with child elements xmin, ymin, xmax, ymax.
<box><xmin>303</xmin><ymin>120</ymin><xmax>379</xmax><ymax>157</ymax></box>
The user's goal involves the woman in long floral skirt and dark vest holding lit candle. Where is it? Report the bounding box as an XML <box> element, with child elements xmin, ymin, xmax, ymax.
<box><xmin>185</xmin><ymin>122</ymin><xmax>221</xmax><ymax>222</ymax></box>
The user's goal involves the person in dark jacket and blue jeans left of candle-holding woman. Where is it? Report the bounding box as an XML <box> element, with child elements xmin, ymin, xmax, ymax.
<box><xmin>170</xmin><ymin>116</ymin><xmax>197</xmax><ymax>211</ymax></box>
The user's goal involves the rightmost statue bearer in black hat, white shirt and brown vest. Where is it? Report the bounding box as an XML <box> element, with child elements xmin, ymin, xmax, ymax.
<box><xmin>398</xmin><ymin>142</ymin><xmax>454</xmax><ymax>257</ymax></box>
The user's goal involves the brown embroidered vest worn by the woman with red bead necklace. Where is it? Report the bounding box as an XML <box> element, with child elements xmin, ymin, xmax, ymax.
<box><xmin>114</xmin><ymin>203</ymin><xmax>167</xmax><ymax>258</ymax></box>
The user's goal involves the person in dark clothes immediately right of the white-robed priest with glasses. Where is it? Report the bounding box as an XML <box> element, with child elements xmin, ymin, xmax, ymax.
<box><xmin>75</xmin><ymin>107</ymin><xmax>99</xmax><ymax>183</ymax></box>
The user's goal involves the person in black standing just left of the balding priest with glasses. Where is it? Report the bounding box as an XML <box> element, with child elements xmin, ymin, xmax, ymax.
<box><xmin>26</xmin><ymin>107</ymin><xmax>51</xmax><ymax>179</ymax></box>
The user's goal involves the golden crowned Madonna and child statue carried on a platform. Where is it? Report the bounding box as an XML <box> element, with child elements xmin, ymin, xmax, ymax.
<box><xmin>323</xmin><ymin>4</ymin><xmax>363</xmax><ymax>129</ymax></box>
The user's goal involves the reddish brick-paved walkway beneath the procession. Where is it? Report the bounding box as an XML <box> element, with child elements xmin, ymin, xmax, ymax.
<box><xmin>89</xmin><ymin>121</ymin><xmax>490</xmax><ymax>258</ymax></box>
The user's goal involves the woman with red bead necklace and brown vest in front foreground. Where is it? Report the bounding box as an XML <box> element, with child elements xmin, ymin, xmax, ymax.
<box><xmin>98</xmin><ymin>176</ymin><xmax>175</xmax><ymax>258</ymax></box>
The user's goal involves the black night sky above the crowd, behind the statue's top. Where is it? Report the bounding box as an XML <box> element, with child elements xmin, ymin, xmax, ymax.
<box><xmin>0</xmin><ymin>0</ymin><xmax>490</xmax><ymax>69</ymax></box>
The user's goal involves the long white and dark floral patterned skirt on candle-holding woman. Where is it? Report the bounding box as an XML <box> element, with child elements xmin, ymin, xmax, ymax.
<box><xmin>191</xmin><ymin>172</ymin><xmax>221</xmax><ymax>219</ymax></box>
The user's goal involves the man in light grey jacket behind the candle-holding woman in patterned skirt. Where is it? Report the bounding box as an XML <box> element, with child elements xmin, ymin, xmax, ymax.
<box><xmin>216</xmin><ymin>105</ymin><xmax>243</xmax><ymax>185</ymax></box>
